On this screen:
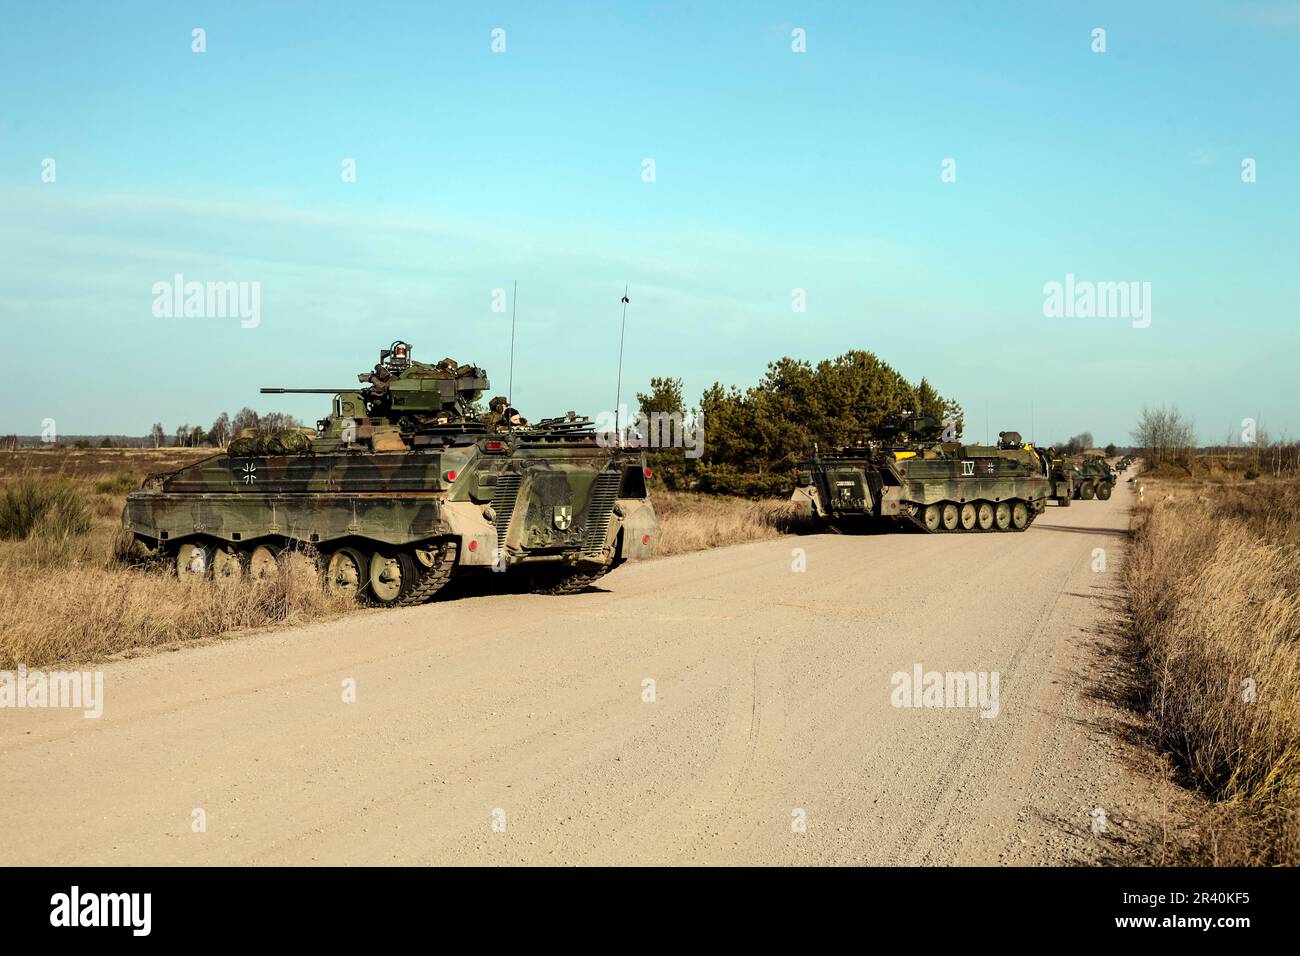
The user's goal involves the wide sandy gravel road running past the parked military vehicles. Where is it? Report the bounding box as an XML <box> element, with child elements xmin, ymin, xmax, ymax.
<box><xmin>0</xmin><ymin>483</ymin><xmax>1151</xmax><ymax>864</ymax></box>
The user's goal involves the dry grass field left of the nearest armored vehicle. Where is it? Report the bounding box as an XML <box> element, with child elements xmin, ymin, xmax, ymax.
<box><xmin>0</xmin><ymin>453</ymin><xmax>350</xmax><ymax>670</ymax></box>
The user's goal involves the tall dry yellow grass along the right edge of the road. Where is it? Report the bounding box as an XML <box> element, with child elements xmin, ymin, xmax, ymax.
<box><xmin>1126</xmin><ymin>476</ymin><xmax>1300</xmax><ymax>865</ymax></box>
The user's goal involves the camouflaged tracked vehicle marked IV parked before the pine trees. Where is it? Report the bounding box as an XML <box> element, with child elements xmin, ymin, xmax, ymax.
<box><xmin>792</xmin><ymin>416</ymin><xmax>1052</xmax><ymax>533</ymax></box>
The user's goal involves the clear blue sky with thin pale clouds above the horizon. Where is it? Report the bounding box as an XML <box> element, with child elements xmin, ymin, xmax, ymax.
<box><xmin>0</xmin><ymin>0</ymin><xmax>1300</xmax><ymax>442</ymax></box>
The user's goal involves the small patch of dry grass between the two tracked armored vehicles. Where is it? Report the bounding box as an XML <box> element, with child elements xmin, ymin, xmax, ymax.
<box><xmin>653</xmin><ymin>492</ymin><xmax>802</xmax><ymax>557</ymax></box>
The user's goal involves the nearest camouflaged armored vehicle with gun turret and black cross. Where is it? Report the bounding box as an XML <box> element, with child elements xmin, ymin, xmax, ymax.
<box><xmin>122</xmin><ymin>342</ymin><xmax>655</xmax><ymax>605</ymax></box>
